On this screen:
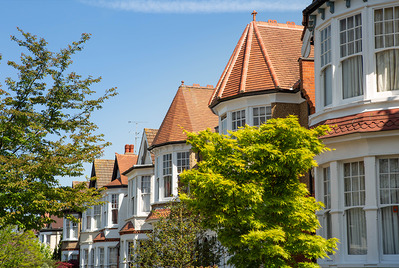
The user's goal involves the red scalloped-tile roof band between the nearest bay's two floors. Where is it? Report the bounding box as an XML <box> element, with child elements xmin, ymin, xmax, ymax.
<box><xmin>315</xmin><ymin>109</ymin><xmax>399</xmax><ymax>138</ymax></box>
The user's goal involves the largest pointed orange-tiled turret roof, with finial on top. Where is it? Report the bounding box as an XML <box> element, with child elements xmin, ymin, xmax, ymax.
<box><xmin>209</xmin><ymin>20</ymin><xmax>303</xmax><ymax>107</ymax></box>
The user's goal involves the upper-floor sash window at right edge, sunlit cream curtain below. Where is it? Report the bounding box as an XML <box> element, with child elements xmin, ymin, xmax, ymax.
<box><xmin>374</xmin><ymin>6</ymin><xmax>399</xmax><ymax>92</ymax></box>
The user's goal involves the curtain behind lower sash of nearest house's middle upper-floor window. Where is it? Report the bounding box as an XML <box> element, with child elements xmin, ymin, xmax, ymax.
<box><xmin>342</xmin><ymin>55</ymin><xmax>363</xmax><ymax>99</ymax></box>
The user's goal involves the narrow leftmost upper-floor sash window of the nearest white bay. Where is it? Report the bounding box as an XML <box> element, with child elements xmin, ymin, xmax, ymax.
<box><xmin>320</xmin><ymin>25</ymin><xmax>332</xmax><ymax>106</ymax></box>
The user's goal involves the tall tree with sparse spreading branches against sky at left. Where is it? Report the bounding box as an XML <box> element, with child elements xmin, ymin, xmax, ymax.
<box><xmin>0</xmin><ymin>29</ymin><xmax>115</xmax><ymax>230</ymax></box>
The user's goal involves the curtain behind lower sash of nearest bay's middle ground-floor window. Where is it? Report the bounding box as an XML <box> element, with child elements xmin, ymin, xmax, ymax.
<box><xmin>346</xmin><ymin>208</ymin><xmax>367</xmax><ymax>255</ymax></box>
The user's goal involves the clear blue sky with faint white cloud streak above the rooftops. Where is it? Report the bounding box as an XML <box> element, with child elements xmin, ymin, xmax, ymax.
<box><xmin>0</xmin><ymin>0</ymin><xmax>312</xmax><ymax>186</ymax></box>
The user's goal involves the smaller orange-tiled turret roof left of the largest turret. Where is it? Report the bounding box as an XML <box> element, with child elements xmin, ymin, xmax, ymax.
<box><xmin>150</xmin><ymin>83</ymin><xmax>218</xmax><ymax>149</ymax></box>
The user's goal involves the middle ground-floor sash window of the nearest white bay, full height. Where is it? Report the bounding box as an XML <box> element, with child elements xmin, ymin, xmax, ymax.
<box><xmin>344</xmin><ymin>161</ymin><xmax>367</xmax><ymax>255</ymax></box>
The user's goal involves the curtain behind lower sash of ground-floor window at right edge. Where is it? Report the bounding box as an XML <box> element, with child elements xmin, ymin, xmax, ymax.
<box><xmin>381</xmin><ymin>206</ymin><xmax>399</xmax><ymax>254</ymax></box>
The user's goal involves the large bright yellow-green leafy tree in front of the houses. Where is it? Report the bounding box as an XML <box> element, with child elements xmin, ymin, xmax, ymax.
<box><xmin>181</xmin><ymin>116</ymin><xmax>337</xmax><ymax>268</ymax></box>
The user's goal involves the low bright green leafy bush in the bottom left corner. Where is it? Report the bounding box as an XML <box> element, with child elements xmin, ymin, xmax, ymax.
<box><xmin>0</xmin><ymin>225</ymin><xmax>54</xmax><ymax>268</ymax></box>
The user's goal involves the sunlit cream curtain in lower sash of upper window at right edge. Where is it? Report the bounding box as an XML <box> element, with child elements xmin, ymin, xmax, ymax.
<box><xmin>376</xmin><ymin>49</ymin><xmax>399</xmax><ymax>92</ymax></box>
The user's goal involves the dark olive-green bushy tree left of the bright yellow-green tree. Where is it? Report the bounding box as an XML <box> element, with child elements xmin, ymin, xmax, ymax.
<box><xmin>131</xmin><ymin>201</ymin><xmax>223</xmax><ymax>267</ymax></box>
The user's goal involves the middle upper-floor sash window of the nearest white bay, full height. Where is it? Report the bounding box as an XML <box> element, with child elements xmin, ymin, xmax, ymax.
<box><xmin>339</xmin><ymin>14</ymin><xmax>363</xmax><ymax>99</ymax></box>
